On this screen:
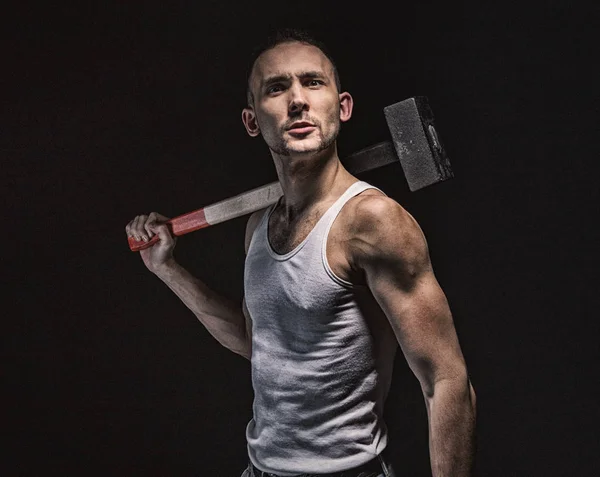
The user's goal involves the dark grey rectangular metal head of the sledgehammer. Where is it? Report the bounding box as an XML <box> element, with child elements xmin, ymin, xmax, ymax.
<box><xmin>383</xmin><ymin>96</ymin><xmax>454</xmax><ymax>192</ymax></box>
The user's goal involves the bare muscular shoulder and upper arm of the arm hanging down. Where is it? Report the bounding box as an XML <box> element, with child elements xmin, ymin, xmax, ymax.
<box><xmin>358</xmin><ymin>200</ymin><xmax>464</xmax><ymax>393</ymax></box>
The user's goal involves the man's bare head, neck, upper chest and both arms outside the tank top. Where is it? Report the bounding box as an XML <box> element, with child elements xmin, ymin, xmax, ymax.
<box><xmin>126</xmin><ymin>41</ymin><xmax>476</xmax><ymax>477</ymax></box>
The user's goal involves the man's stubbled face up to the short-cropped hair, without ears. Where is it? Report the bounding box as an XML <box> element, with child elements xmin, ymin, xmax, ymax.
<box><xmin>245</xmin><ymin>42</ymin><xmax>340</xmax><ymax>156</ymax></box>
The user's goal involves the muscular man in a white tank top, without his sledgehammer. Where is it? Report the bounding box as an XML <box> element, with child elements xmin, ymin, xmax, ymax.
<box><xmin>126</xmin><ymin>31</ymin><xmax>475</xmax><ymax>477</ymax></box>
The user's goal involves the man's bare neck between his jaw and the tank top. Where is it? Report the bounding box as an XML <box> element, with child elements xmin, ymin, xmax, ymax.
<box><xmin>273</xmin><ymin>143</ymin><xmax>354</xmax><ymax>221</ymax></box>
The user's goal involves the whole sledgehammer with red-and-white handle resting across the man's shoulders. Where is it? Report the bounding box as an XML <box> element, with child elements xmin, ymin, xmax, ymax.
<box><xmin>128</xmin><ymin>96</ymin><xmax>454</xmax><ymax>252</ymax></box>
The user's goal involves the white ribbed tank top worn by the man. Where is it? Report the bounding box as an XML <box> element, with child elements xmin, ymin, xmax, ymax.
<box><xmin>244</xmin><ymin>181</ymin><xmax>397</xmax><ymax>476</ymax></box>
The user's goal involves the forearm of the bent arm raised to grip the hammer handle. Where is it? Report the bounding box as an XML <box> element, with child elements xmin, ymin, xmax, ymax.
<box><xmin>155</xmin><ymin>261</ymin><xmax>250</xmax><ymax>359</ymax></box>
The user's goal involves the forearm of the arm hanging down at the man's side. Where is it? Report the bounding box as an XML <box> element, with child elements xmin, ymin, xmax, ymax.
<box><xmin>426</xmin><ymin>379</ymin><xmax>476</xmax><ymax>477</ymax></box>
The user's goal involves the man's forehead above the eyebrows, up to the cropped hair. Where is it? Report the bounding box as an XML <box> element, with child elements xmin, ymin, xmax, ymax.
<box><xmin>253</xmin><ymin>42</ymin><xmax>333</xmax><ymax>83</ymax></box>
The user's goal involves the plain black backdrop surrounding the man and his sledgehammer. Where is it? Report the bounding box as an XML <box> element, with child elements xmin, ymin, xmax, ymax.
<box><xmin>1</xmin><ymin>2</ymin><xmax>600</xmax><ymax>477</ymax></box>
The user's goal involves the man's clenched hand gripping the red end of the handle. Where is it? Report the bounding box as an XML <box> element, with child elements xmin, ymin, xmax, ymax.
<box><xmin>125</xmin><ymin>212</ymin><xmax>177</xmax><ymax>274</ymax></box>
